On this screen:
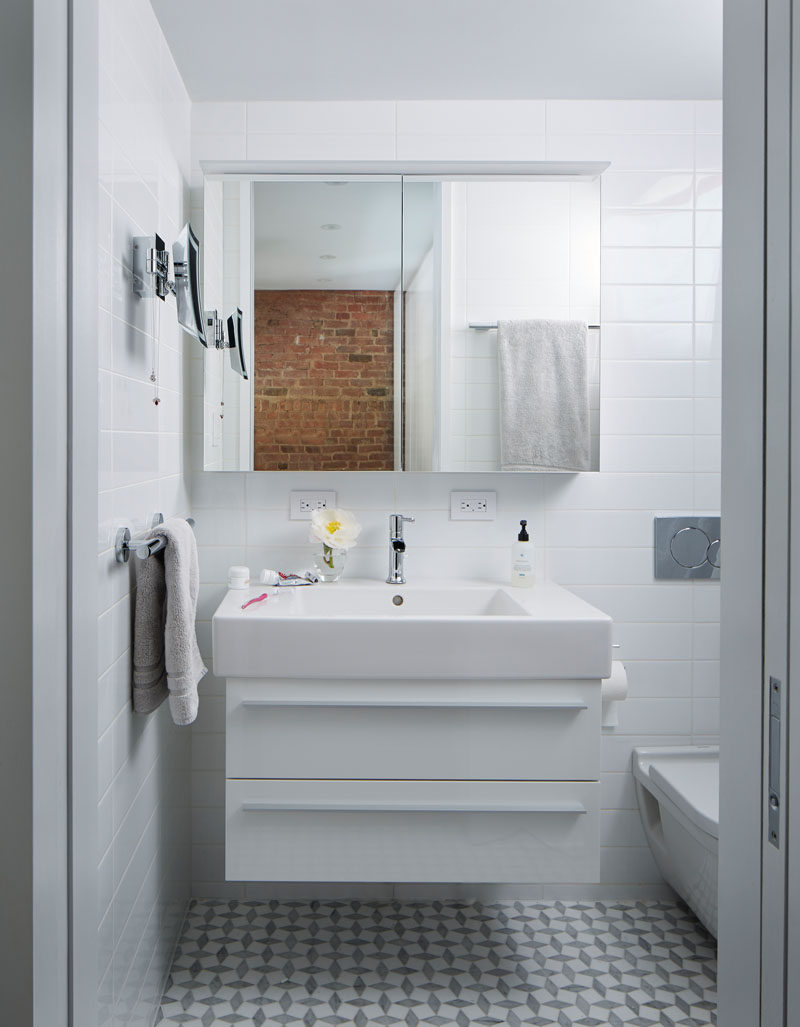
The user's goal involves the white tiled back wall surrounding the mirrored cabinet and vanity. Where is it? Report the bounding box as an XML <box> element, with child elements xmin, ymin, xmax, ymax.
<box><xmin>192</xmin><ymin>101</ymin><xmax>722</xmax><ymax>896</ymax></box>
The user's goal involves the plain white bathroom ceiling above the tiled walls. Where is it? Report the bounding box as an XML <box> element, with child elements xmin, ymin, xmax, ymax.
<box><xmin>152</xmin><ymin>0</ymin><xmax>722</xmax><ymax>101</ymax></box>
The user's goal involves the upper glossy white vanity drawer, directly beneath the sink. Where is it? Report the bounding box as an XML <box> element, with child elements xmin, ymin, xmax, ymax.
<box><xmin>227</xmin><ymin>680</ymin><xmax>601</xmax><ymax>781</ymax></box>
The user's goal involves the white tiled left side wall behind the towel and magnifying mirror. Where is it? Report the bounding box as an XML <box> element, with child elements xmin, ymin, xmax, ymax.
<box><xmin>98</xmin><ymin>0</ymin><xmax>191</xmax><ymax>1027</ymax></box>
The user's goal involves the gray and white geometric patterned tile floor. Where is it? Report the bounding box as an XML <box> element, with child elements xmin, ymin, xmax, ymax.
<box><xmin>156</xmin><ymin>901</ymin><xmax>717</xmax><ymax>1027</ymax></box>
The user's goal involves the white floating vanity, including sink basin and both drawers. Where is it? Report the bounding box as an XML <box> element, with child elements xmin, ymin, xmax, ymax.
<box><xmin>213</xmin><ymin>581</ymin><xmax>611</xmax><ymax>883</ymax></box>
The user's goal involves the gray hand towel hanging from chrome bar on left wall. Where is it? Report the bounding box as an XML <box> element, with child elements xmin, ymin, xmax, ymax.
<box><xmin>134</xmin><ymin>518</ymin><xmax>207</xmax><ymax>725</ymax></box>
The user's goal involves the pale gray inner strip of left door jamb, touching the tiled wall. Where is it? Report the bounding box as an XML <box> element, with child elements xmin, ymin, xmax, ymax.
<box><xmin>68</xmin><ymin>0</ymin><xmax>101</xmax><ymax>1027</ymax></box>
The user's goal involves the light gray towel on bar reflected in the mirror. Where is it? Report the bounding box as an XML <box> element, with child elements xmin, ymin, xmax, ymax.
<box><xmin>497</xmin><ymin>320</ymin><xmax>589</xmax><ymax>470</ymax></box>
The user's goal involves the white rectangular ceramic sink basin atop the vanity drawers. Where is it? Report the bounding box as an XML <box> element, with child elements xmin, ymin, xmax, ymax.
<box><xmin>213</xmin><ymin>580</ymin><xmax>611</xmax><ymax>679</ymax></box>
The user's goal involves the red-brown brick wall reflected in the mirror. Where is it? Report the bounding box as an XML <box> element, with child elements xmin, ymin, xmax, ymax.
<box><xmin>254</xmin><ymin>290</ymin><xmax>394</xmax><ymax>470</ymax></box>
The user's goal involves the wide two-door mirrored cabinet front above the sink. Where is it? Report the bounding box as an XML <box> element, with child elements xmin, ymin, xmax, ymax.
<box><xmin>203</xmin><ymin>174</ymin><xmax>600</xmax><ymax>472</ymax></box>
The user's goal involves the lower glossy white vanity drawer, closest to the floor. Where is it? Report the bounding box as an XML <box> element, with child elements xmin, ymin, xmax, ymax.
<box><xmin>225</xmin><ymin>781</ymin><xmax>600</xmax><ymax>883</ymax></box>
